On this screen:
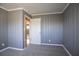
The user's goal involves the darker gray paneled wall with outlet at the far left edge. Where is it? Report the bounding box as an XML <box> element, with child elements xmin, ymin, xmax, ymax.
<box><xmin>0</xmin><ymin>8</ymin><xmax>8</xmax><ymax>49</ymax></box>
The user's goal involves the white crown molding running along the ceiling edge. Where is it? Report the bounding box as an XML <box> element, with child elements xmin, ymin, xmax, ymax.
<box><xmin>0</xmin><ymin>3</ymin><xmax>70</xmax><ymax>16</ymax></box>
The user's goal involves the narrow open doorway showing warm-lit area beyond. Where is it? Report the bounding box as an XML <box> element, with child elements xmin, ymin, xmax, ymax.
<box><xmin>24</xmin><ymin>17</ymin><xmax>30</xmax><ymax>47</ymax></box>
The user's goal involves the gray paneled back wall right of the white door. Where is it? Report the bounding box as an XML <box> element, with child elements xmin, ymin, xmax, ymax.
<box><xmin>41</xmin><ymin>14</ymin><xmax>63</xmax><ymax>44</ymax></box>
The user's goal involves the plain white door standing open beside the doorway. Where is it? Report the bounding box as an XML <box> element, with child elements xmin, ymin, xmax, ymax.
<box><xmin>30</xmin><ymin>18</ymin><xmax>41</xmax><ymax>44</ymax></box>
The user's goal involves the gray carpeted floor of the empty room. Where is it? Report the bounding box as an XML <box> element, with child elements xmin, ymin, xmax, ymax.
<box><xmin>0</xmin><ymin>45</ymin><xmax>68</xmax><ymax>56</ymax></box>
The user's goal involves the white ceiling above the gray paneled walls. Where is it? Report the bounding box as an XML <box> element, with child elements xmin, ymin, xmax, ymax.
<box><xmin>0</xmin><ymin>3</ymin><xmax>68</xmax><ymax>15</ymax></box>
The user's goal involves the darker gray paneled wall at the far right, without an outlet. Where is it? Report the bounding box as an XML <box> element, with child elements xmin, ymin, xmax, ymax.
<box><xmin>64</xmin><ymin>4</ymin><xmax>79</xmax><ymax>55</ymax></box>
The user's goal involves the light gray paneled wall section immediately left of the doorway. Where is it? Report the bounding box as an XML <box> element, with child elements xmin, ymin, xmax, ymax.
<box><xmin>8</xmin><ymin>10</ymin><xmax>23</xmax><ymax>48</ymax></box>
